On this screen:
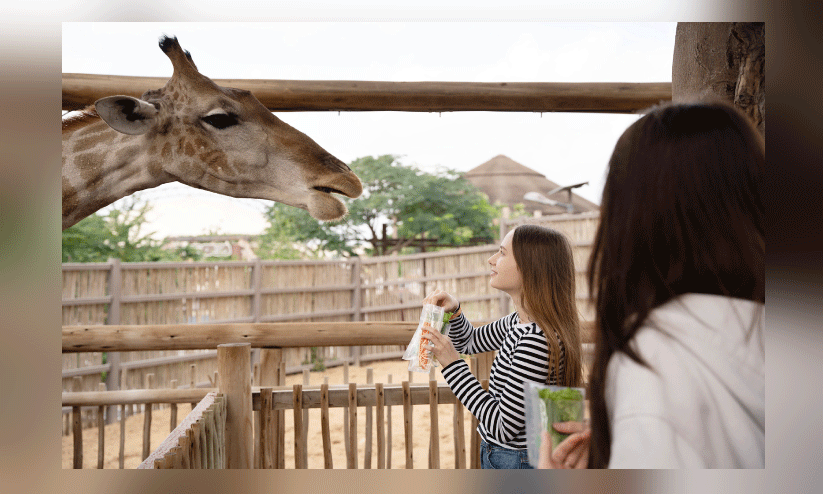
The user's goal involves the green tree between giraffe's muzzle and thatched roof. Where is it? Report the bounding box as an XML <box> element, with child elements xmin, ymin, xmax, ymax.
<box><xmin>257</xmin><ymin>155</ymin><xmax>498</xmax><ymax>259</ymax></box>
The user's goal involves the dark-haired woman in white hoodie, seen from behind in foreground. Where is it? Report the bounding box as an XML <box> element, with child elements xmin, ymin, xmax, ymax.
<box><xmin>540</xmin><ymin>99</ymin><xmax>766</xmax><ymax>468</ymax></box>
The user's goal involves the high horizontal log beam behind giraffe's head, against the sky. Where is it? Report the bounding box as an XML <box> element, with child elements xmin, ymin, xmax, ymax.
<box><xmin>63</xmin><ymin>73</ymin><xmax>672</xmax><ymax>113</ymax></box>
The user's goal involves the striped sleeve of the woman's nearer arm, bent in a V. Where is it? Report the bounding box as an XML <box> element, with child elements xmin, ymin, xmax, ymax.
<box><xmin>442</xmin><ymin>332</ymin><xmax>549</xmax><ymax>444</ymax></box>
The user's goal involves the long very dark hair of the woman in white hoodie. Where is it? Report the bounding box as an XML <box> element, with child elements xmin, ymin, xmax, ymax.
<box><xmin>588</xmin><ymin>102</ymin><xmax>766</xmax><ymax>468</ymax></box>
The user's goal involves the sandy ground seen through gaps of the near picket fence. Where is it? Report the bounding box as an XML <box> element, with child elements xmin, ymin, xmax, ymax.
<box><xmin>62</xmin><ymin>360</ymin><xmax>472</xmax><ymax>469</ymax></box>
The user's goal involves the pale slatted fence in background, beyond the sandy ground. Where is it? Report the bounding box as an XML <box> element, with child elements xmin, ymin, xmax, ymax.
<box><xmin>62</xmin><ymin>213</ymin><xmax>598</xmax><ymax>433</ymax></box>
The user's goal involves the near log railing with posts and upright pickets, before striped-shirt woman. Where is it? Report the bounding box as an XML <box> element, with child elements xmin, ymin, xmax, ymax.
<box><xmin>63</xmin><ymin>322</ymin><xmax>591</xmax><ymax>468</ymax></box>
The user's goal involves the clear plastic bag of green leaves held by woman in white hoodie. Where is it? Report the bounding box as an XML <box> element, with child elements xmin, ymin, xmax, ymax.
<box><xmin>525</xmin><ymin>382</ymin><xmax>586</xmax><ymax>468</ymax></box>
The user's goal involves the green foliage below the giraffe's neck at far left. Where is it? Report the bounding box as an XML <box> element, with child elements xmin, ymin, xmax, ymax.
<box><xmin>62</xmin><ymin>196</ymin><xmax>200</xmax><ymax>262</ymax></box>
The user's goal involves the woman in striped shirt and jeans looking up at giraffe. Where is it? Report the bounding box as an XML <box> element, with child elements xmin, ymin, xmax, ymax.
<box><xmin>424</xmin><ymin>225</ymin><xmax>582</xmax><ymax>468</ymax></box>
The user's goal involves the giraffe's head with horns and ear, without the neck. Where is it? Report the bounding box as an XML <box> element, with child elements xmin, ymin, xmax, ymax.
<box><xmin>95</xmin><ymin>36</ymin><xmax>362</xmax><ymax>220</ymax></box>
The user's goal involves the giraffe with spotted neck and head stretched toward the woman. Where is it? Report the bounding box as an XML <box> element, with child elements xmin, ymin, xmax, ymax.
<box><xmin>62</xmin><ymin>36</ymin><xmax>362</xmax><ymax>230</ymax></box>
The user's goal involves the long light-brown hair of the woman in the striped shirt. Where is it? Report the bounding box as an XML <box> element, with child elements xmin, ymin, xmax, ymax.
<box><xmin>512</xmin><ymin>225</ymin><xmax>583</xmax><ymax>386</ymax></box>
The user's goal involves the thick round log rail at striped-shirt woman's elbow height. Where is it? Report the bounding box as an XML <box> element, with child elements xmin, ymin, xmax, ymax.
<box><xmin>62</xmin><ymin>321</ymin><xmax>593</xmax><ymax>353</ymax></box>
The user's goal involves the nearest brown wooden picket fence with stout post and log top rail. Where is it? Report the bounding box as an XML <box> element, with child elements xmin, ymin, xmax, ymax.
<box><xmin>62</xmin><ymin>322</ymin><xmax>512</xmax><ymax>468</ymax></box>
